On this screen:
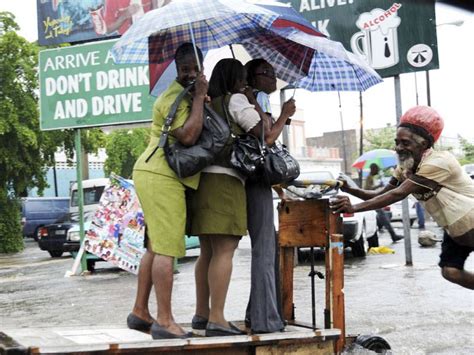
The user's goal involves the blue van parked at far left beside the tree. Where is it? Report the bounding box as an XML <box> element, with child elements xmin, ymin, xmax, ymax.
<box><xmin>21</xmin><ymin>197</ymin><xmax>69</xmax><ymax>240</ymax></box>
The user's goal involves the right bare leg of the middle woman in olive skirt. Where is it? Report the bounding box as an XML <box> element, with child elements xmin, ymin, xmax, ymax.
<box><xmin>208</xmin><ymin>236</ymin><xmax>239</xmax><ymax>327</ymax></box>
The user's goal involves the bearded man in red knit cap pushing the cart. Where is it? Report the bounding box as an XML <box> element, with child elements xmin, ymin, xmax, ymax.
<box><xmin>331</xmin><ymin>106</ymin><xmax>474</xmax><ymax>289</ymax></box>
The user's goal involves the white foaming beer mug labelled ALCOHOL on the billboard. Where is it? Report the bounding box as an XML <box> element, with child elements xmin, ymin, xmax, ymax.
<box><xmin>351</xmin><ymin>4</ymin><xmax>401</xmax><ymax>69</ymax></box>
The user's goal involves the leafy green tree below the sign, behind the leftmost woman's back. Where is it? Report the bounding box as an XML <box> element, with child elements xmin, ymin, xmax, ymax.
<box><xmin>104</xmin><ymin>128</ymin><xmax>150</xmax><ymax>179</ymax></box>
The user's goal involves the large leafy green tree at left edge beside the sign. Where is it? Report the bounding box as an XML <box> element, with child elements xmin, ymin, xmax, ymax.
<box><xmin>0</xmin><ymin>12</ymin><xmax>103</xmax><ymax>253</ymax></box>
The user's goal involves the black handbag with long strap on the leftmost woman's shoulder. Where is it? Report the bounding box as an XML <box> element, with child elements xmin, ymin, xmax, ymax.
<box><xmin>146</xmin><ymin>86</ymin><xmax>230</xmax><ymax>178</ymax></box>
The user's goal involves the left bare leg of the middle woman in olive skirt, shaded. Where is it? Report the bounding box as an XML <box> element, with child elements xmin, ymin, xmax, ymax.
<box><xmin>194</xmin><ymin>237</ymin><xmax>212</xmax><ymax>318</ymax></box>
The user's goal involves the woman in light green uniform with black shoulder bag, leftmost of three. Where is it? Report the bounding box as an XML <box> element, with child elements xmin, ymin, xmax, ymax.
<box><xmin>127</xmin><ymin>43</ymin><xmax>208</xmax><ymax>339</ymax></box>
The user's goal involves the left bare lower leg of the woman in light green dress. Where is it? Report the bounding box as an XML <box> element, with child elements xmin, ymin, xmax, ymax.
<box><xmin>132</xmin><ymin>250</ymin><xmax>154</xmax><ymax>323</ymax></box>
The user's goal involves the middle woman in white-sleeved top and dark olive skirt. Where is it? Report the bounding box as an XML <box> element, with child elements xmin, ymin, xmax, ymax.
<box><xmin>191</xmin><ymin>59</ymin><xmax>261</xmax><ymax>336</ymax></box>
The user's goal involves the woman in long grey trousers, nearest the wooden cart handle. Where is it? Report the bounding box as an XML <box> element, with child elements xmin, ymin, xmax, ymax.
<box><xmin>245</xmin><ymin>59</ymin><xmax>296</xmax><ymax>333</ymax></box>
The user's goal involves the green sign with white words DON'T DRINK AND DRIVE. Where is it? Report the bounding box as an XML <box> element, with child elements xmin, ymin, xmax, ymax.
<box><xmin>39</xmin><ymin>40</ymin><xmax>155</xmax><ymax>130</ymax></box>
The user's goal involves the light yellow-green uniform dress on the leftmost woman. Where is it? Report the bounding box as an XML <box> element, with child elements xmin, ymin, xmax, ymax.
<box><xmin>133</xmin><ymin>81</ymin><xmax>200</xmax><ymax>257</ymax></box>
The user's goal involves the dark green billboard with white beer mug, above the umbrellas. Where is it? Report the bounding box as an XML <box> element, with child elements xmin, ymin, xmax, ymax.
<box><xmin>281</xmin><ymin>0</ymin><xmax>439</xmax><ymax>77</ymax></box>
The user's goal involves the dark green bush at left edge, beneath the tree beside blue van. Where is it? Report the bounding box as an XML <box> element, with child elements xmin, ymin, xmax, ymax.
<box><xmin>0</xmin><ymin>190</ymin><xmax>24</xmax><ymax>253</ymax></box>
